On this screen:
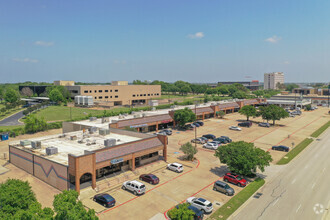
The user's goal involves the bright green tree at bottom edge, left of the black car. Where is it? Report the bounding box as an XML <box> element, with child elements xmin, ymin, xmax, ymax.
<box><xmin>53</xmin><ymin>190</ymin><xmax>98</xmax><ymax>220</ymax></box>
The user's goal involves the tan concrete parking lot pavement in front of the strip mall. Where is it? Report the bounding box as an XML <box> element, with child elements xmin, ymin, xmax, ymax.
<box><xmin>83</xmin><ymin>108</ymin><xmax>329</xmax><ymax>219</ymax></box>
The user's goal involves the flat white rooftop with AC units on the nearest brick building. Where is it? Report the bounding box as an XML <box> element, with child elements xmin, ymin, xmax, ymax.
<box><xmin>9</xmin><ymin>131</ymin><xmax>143</xmax><ymax>165</ymax></box>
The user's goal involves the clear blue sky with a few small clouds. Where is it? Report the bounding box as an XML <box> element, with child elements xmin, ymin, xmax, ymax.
<box><xmin>0</xmin><ymin>0</ymin><xmax>330</xmax><ymax>83</ymax></box>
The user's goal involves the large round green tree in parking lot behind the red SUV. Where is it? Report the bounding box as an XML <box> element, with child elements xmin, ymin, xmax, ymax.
<box><xmin>215</xmin><ymin>141</ymin><xmax>273</xmax><ymax>176</ymax></box>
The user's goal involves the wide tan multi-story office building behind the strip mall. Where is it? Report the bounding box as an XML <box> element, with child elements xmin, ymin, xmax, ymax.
<box><xmin>66</xmin><ymin>81</ymin><xmax>161</xmax><ymax>106</ymax></box>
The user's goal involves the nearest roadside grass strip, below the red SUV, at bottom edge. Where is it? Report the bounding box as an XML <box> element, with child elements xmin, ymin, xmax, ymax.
<box><xmin>209</xmin><ymin>178</ymin><xmax>265</xmax><ymax>220</ymax></box>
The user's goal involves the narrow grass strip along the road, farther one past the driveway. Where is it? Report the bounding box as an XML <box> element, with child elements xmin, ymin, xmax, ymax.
<box><xmin>276</xmin><ymin>121</ymin><xmax>330</xmax><ymax>165</ymax></box>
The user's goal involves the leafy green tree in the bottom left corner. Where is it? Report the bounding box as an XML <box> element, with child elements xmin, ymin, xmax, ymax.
<box><xmin>0</xmin><ymin>179</ymin><xmax>54</xmax><ymax>219</ymax></box>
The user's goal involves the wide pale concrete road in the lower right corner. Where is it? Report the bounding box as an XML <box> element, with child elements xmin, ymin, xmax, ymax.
<box><xmin>230</xmin><ymin>129</ymin><xmax>330</xmax><ymax>220</ymax></box>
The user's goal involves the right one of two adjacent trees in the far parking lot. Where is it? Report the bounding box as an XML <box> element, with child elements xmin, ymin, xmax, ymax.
<box><xmin>257</xmin><ymin>105</ymin><xmax>289</xmax><ymax>125</ymax></box>
